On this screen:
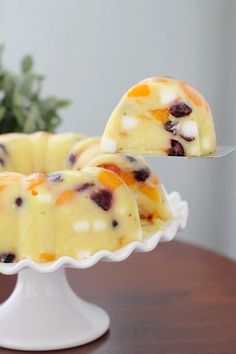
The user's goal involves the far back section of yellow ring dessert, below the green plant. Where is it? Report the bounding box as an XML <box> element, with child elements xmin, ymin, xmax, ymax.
<box><xmin>0</xmin><ymin>132</ymin><xmax>85</xmax><ymax>175</ymax></box>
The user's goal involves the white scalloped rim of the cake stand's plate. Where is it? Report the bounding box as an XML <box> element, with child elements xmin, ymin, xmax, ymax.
<box><xmin>0</xmin><ymin>186</ymin><xmax>188</xmax><ymax>275</ymax></box>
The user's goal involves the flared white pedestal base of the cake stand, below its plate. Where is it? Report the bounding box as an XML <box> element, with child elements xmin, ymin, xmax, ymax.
<box><xmin>0</xmin><ymin>268</ymin><xmax>110</xmax><ymax>351</ymax></box>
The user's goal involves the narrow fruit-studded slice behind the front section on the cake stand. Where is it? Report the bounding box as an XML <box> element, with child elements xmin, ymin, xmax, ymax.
<box><xmin>86</xmin><ymin>154</ymin><xmax>171</xmax><ymax>234</ymax></box>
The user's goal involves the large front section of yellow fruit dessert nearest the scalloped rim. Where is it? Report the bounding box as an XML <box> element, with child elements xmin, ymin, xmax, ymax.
<box><xmin>0</xmin><ymin>167</ymin><xmax>142</xmax><ymax>262</ymax></box>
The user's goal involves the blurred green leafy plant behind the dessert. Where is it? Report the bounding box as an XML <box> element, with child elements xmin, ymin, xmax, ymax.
<box><xmin>0</xmin><ymin>45</ymin><xmax>70</xmax><ymax>134</ymax></box>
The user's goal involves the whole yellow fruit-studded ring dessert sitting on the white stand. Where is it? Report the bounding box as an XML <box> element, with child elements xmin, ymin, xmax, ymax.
<box><xmin>0</xmin><ymin>132</ymin><xmax>170</xmax><ymax>262</ymax></box>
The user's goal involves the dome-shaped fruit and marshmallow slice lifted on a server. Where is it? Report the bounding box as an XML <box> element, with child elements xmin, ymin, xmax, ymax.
<box><xmin>101</xmin><ymin>77</ymin><xmax>216</xmax><ymax>156</ymax></box>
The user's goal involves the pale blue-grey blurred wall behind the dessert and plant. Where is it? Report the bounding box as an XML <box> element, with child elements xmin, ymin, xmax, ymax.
<box><xmin>0</xmin><ymin>0</ymin><xmax>236</xmax><ymax>259</ymax></box>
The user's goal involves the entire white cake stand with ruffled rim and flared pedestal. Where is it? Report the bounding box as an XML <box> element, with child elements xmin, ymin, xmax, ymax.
<box><xmin>0</xmin><ymin>192</ymin><xmax>188</xmax><ymax>351</ymax></box>
